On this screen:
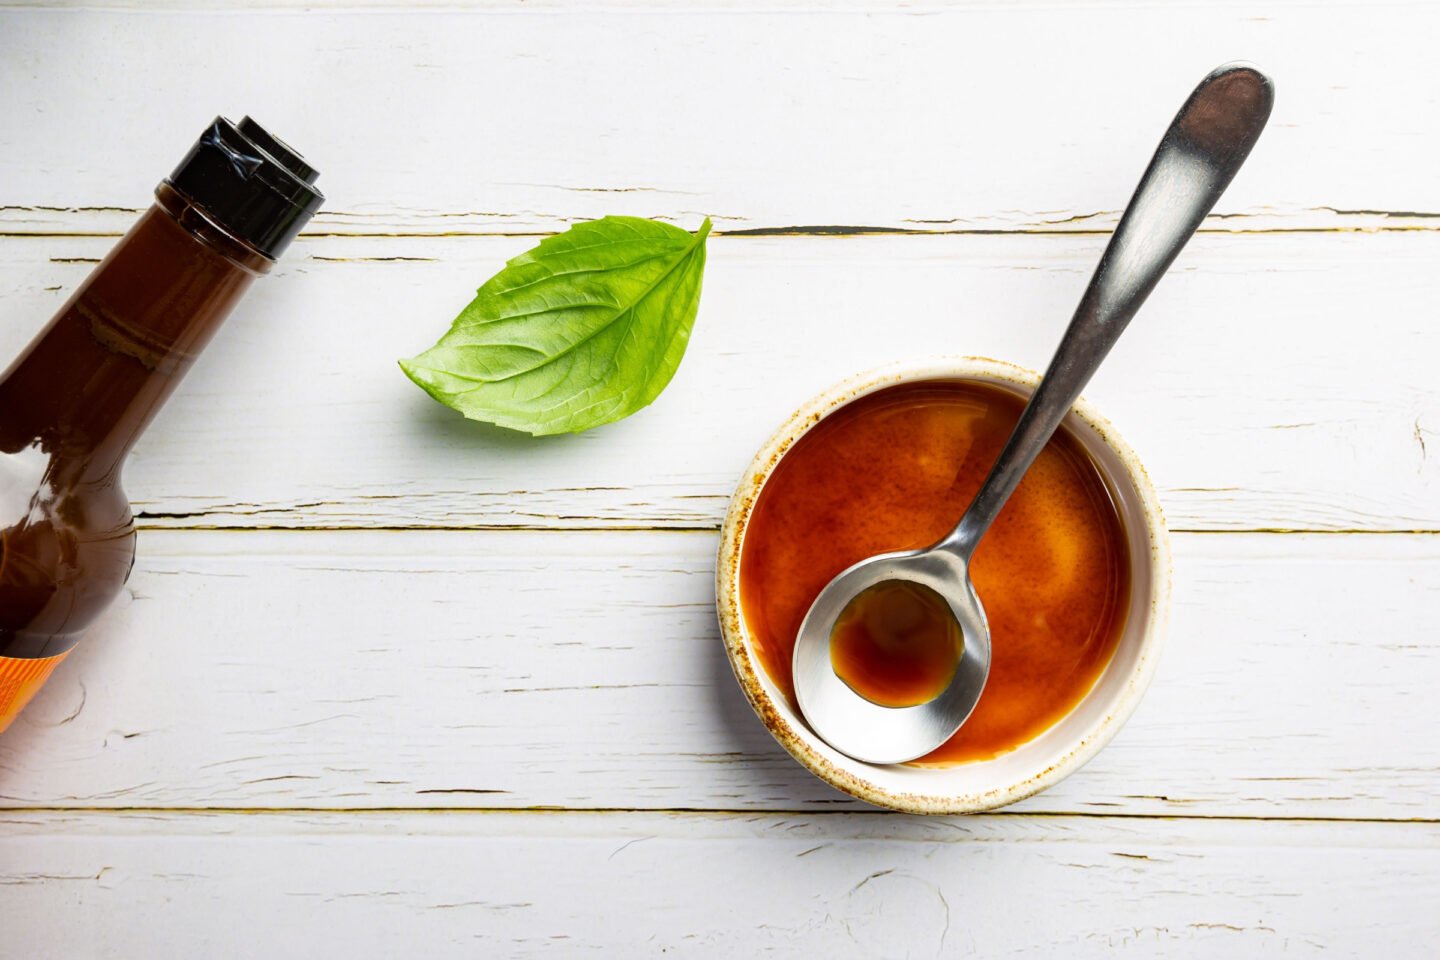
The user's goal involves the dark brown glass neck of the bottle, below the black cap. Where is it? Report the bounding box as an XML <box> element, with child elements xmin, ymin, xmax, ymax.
<box><xmin>0</xmin><ymin>184</ymin><xmax>271</xmax><ymax>479</ymax></box>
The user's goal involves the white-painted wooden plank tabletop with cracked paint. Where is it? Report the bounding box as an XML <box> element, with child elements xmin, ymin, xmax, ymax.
<box><xmin>0</xmin><ymin>0</ymin><xmax>1440</xmax><ymax>957</ymax></box>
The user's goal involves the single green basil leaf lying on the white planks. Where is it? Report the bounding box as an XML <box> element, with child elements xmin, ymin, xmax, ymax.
<box><xmin>400</xmin><ymin>217</ymin><xmax>710</xmax><ymax>436</ymax></box>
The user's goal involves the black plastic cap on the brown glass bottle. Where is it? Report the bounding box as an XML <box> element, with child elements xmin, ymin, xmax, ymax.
<box><xmin>166</xmin><ymin>117</ymin><xmax>325</xmax><ymax>261</ymax></box>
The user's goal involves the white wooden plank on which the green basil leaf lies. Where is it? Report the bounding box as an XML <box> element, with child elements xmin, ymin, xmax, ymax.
<box><xmin>0</xmin><ymin>235</ymin><xmax>1440</xmax><ymax>530</ymax></box>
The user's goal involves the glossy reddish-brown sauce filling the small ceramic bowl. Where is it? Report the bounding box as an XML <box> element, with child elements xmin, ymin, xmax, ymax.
<box><xmin>740</xmin><ymin>380</ymin><xmax>1130</xmax><ymax>764</ymax></box>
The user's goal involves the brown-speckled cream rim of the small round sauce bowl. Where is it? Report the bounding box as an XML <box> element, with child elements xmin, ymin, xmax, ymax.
<box><xmin>716</xmin><ymin>356</ymin><xmax>1172</xmax><ymax>815</ymax></box>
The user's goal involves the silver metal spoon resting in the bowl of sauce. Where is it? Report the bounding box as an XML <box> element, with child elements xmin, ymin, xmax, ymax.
<box><xmin>793</xmin><ymin>63</ymin><xmax>1274</xmax><ymax>763</ymax></box>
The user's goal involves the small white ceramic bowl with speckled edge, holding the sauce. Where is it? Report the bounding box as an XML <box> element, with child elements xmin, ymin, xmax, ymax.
<box><xmin>716</xmin><ymin>357</ymin><xmax>1171</xmax><ymax>813</ymax></box>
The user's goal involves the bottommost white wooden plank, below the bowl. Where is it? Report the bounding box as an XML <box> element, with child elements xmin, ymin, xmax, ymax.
<box><xmin>0</xmin><ymin>813</ymin><xmax>1440</xmax><ymax>957</ymax></box>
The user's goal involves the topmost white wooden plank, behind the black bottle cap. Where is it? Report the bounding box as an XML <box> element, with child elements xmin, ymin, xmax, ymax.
<box><xmin>0</xmin><ymin>0</ymin><xmax>1440</xmax><ymax>233</ymax></box>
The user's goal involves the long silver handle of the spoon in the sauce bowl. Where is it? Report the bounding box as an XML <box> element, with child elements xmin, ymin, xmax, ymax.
<box><xmin>939</xmin><ymin>63</ymin><xmax>1274</xmax><ymax>558</ymax></box>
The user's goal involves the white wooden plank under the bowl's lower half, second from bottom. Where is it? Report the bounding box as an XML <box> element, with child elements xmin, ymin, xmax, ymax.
<box><xmin>0</xmin><ymin>531</ymin><xmax>1440</xmax><ymax>819</ymax></box>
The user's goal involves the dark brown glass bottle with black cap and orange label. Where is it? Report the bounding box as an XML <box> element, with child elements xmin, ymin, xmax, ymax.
<box><xmin>0</xmin><ymin>118</ymin><xmax>323</xmax><ymax>731</ymax></box>
